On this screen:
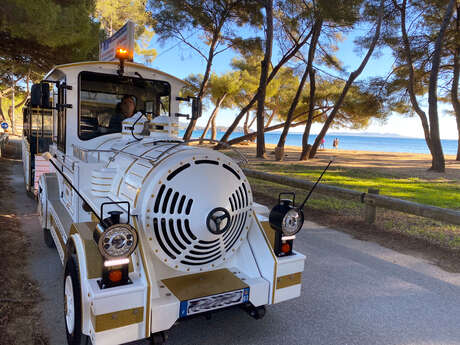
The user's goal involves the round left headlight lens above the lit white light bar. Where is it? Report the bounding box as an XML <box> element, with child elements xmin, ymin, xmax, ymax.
<box><xmin>97</xmin><ymin>224</ymin><xmax>137</xmax><ymax>260</ymax></box>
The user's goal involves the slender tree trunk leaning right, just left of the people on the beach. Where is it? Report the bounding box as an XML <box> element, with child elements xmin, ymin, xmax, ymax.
<box><xmin>310</xmin><ymin>0</ymin><xmax>385</xmax><ymax>158</ymax></box>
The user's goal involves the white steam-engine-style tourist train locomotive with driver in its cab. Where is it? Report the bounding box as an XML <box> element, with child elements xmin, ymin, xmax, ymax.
<box><xmin>23</xmin><ymin>51</ymin><xmax>305</xmax><ymax>345</ymax></box>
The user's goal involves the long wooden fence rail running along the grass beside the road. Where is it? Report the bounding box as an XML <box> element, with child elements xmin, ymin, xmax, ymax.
<box><xmin>243</xmin><ymin>169</ymin><xmax>460</xmax><ymax>225</ymax></box>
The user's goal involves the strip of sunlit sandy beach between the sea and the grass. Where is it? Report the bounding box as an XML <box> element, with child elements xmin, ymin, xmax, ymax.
<box><xmin>235</xmin><ymin>143</ymin><xmax>460</xmax><ymax>181</ymax></box>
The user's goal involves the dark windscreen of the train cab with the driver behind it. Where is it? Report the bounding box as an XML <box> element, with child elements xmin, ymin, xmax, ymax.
<box><xmin>78</xmin><ymin>72</ymin><xmax>171</xmax><ymax>140</ymax></box>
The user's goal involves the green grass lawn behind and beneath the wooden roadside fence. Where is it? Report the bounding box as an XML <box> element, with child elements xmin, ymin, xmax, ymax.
<box><xmin>247</xmin><ymin>161</ymin><xmax>460</xmax><ymax>251</ymax></box>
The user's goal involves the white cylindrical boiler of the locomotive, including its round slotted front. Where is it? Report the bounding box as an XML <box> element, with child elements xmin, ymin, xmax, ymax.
<box><xmin>99</xmin><ymin>137</ymin><xmax>253</xmax><ymax>272</ymax></box>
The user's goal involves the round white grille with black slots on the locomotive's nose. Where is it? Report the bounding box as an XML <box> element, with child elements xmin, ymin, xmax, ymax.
<box><xmin>144</xmin><ymin>153</ymin><xmax>252</xmax><ymax>271</ymax></box>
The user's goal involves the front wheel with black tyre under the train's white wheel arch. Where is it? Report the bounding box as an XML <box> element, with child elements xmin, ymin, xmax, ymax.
<box><xmin>64</xmin><ymin>254</ymin><xmax>90</xmax><ymax>345</ymax></box>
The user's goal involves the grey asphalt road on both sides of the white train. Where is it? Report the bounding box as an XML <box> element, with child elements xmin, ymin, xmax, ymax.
<box><xmin>9</xmin><ymin>163</ymin><xmax>460</xmax><ymax>345</ymax></box>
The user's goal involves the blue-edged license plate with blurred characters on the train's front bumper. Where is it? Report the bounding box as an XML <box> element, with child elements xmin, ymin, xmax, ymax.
<box><xmin>179</xmin><ymin>288</ymin><xmax>249</xmax><ymax>317</ymax></box>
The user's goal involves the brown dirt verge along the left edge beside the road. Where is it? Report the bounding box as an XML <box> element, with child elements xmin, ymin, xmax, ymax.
<box><xmin>0</xmin><ymin>150</ymin><xmax>48</xmax><ymax>345</ymax></box>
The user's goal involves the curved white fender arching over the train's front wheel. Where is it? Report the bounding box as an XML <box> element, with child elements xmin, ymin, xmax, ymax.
<box><xmin>66</xmin><ymin>234</ymin><xmax>91</xmax><ymax>335</ymax></box>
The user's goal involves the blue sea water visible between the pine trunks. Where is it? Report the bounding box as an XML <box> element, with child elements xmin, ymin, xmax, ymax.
<box><xmin>180</xmin><ymin>130</ymin><xmax>457</xmax><ymax>155</ymax></box>
